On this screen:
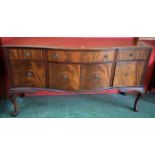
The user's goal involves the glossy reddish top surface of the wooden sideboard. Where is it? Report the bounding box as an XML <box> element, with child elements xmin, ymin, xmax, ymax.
<box><xmin>0</xmin><ymin>37</ymin><xmax>140</xmax><ymax>49</ymax></box>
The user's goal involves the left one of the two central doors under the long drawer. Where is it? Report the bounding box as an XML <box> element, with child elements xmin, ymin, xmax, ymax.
<box><xmin>49</xmin><ymin>63</ymin><xmax>80</xmax><ymax>90</ymax></box>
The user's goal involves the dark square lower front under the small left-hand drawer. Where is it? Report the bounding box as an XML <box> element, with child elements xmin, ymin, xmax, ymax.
<box><xmin>10</xmin><ymin>61</ymin><xmax>45</xmax><ymax>87</ymax></box>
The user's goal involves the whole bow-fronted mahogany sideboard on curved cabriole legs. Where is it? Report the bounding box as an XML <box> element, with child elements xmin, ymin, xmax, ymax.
<box><xmin>1</xmin><ymin>37</ymin><xmax>152</xmax><ymax>115</ymax></box>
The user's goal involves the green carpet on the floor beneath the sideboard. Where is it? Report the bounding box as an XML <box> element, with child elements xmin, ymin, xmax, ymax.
<box><xmin>0</xmin><ymin>94</ymin><xmax>155</xmax><ymax>118</ymax></box>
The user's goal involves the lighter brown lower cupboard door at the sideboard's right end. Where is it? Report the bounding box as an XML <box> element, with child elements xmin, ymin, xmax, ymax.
<box><xmin>113</xmin><ymin>61</ymin><xmax>145</xmax><ymax>87</ymax></box>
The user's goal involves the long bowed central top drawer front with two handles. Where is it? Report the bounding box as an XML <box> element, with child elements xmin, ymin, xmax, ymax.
<box><xmin>48</xmin><ymin>50</ymin><xmax>115</xmax><ymax>63</ymax></box>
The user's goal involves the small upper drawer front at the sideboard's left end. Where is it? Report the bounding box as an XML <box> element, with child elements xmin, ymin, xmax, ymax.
<box><xmin>9</xmin><ymin>48</ymin><xmax>45</xmax><ymax>60</ymax></box>
